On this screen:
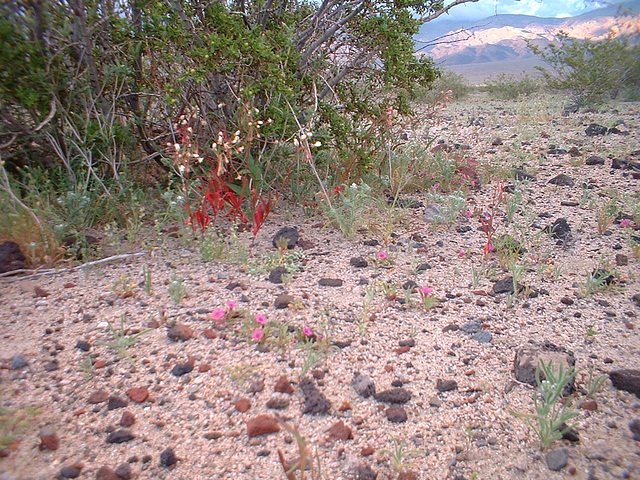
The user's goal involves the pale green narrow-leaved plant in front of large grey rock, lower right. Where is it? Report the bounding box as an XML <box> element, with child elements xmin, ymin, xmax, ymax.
<box><xmin>509</xmin><ymin>360</ymin><xmax>579</xmax><ymax>448</ymax></box>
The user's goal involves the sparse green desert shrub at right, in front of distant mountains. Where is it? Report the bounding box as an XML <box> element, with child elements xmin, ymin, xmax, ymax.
<box><xmin>530</xmin><ymin>33</ymin><xmax>640</xmax><ymax>105</ymax></box>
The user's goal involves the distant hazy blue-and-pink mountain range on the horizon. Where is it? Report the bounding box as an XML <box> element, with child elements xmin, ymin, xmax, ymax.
<box><xmin>415</xmin><ymin>0</ymin><xmax>640</xmax><ymax>83</ymax></box>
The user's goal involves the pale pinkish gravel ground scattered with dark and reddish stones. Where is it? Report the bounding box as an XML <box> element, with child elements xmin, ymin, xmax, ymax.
<box><xmin>0</xmin><ymin>92</ymin><xmax>640</xmax><ymax>480</ymax></box>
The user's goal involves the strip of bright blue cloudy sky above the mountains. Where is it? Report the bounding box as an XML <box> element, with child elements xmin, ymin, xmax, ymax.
<box><xmin>440</xmin><ymin>0</ymin><xmax>604</xmax><ymax>20</ymax></box>
